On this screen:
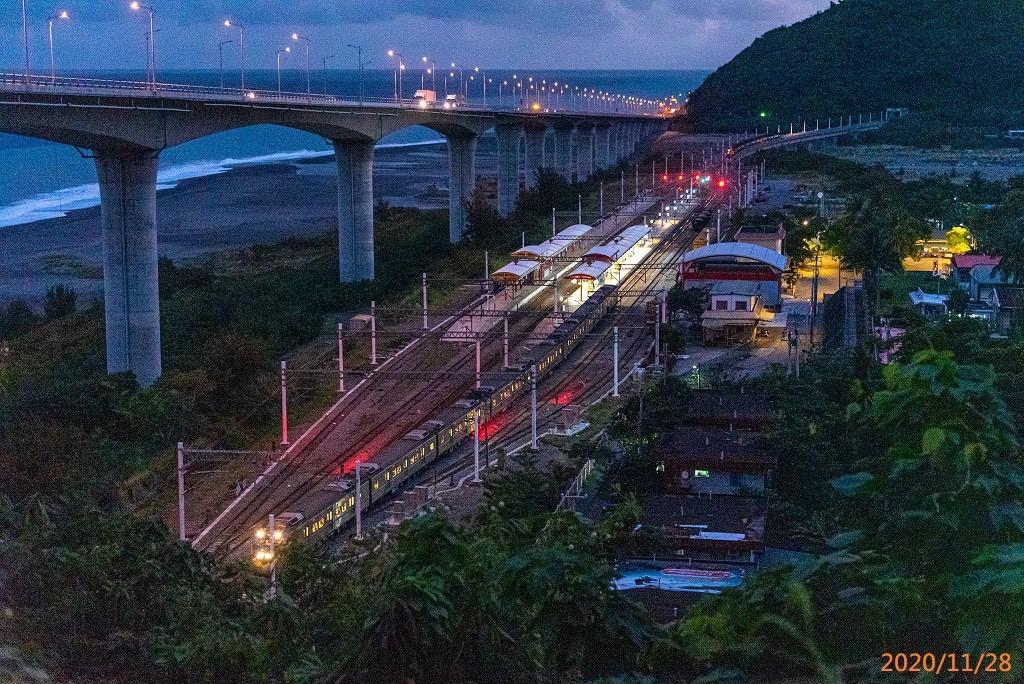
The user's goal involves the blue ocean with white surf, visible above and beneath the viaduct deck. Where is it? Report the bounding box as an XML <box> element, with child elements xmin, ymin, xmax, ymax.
<box><xmin>0</xmin><ymin>70</ymin><xmax>708</xmax><ymax>228</ymax></box>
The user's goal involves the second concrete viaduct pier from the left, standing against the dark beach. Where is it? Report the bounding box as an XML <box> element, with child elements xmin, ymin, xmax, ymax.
<box><xmin>334</xmin><ymin>140</ymin><xmax>374</xmax><ymax>283</ymax></box>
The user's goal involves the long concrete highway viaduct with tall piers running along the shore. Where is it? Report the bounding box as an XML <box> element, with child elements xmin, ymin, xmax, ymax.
<box><xmin>0</xmin><ymin>79</ymin><xmax>666</xmax><ymax>386</ymax></box>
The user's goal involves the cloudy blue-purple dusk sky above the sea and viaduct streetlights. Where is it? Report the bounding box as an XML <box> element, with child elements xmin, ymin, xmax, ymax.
<box><xmin>0</xmin><ymin>0</ymin><xmax>829</xmax><ymax>71</ymax></box>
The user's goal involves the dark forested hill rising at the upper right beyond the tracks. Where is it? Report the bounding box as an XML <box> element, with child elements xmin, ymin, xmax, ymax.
<box><xmin>687</xmin><ymin>0</ymin><xmax>1024</xmax><ymax>141</ymax></box>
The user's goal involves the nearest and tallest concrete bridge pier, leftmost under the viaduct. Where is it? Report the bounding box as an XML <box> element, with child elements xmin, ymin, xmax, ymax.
<box><xmin>95</xmin><ymin>151</ymin><xmax>162</xmax><ymax>387</ymax></box>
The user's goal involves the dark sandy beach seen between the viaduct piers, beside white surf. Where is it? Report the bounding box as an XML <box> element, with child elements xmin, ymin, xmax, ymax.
<box><xmin>0</xmin><ymin>138</ymin><xmax>494</xmax><ymax>303</ymax></box>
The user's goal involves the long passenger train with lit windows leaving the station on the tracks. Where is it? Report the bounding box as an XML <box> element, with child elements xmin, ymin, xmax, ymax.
<box><xmin>289</xmin><ymin>285</ymin><xmax>617</xmax><ymax>544</ymax></box>
